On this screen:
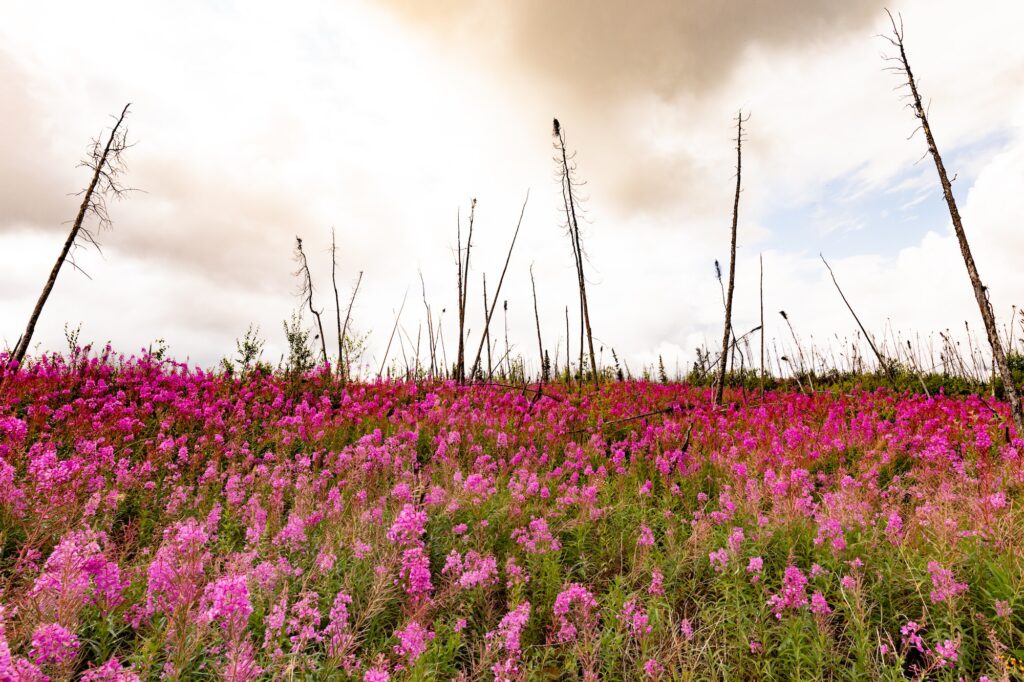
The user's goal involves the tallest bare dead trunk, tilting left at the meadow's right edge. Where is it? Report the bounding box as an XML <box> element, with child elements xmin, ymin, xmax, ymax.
<box><xmin>885</xmin><ymin>9</ymin><xmax>1024</xmax><ymax>435</ymax></box>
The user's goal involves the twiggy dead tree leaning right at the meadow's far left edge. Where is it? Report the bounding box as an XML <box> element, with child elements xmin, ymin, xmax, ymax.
<box><xmin>11</xmin><ymin>102</ymin><xmax>131</xmax><ymax>365</ymax></box>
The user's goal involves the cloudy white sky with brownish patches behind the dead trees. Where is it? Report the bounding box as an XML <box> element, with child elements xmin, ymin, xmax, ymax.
<box><xmin>0</xmin><ymin>0</ymin><xmax>1024</xmax><ymax>373</ymax></box>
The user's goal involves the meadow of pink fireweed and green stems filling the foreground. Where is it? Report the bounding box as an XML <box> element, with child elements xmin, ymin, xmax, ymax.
<box><xmin>0</xmin><ymin>353</ymin><xmax>1024</xmax><ymax>682</ymax></box>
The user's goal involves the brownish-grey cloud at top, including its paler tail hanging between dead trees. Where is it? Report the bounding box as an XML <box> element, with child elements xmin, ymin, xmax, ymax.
<box><xmin>383</xmin><ymin>0</ymin><xmax>882</xmax><ymax>224</ymax></box>
